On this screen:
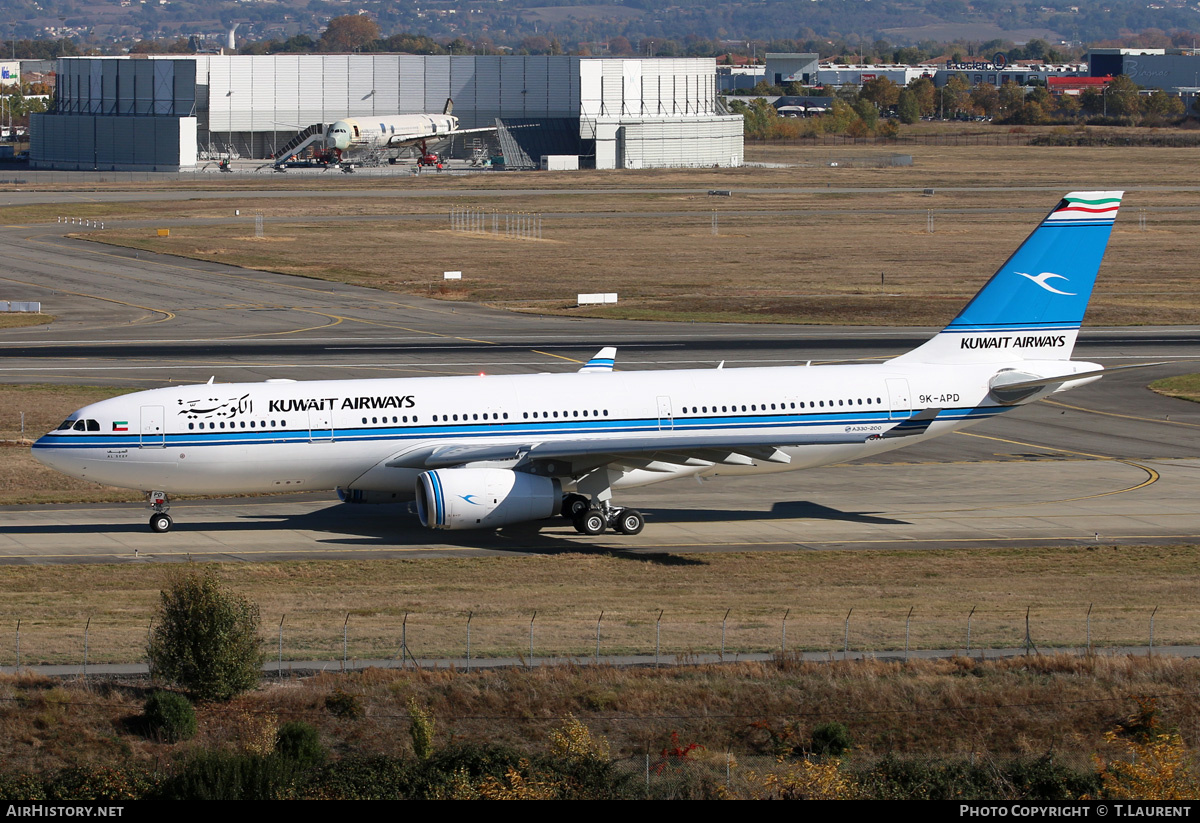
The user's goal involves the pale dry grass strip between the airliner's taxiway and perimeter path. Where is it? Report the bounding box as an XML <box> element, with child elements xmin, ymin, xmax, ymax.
<box><xmin>0</xmin><ymin>546</ymin><xmax>1200</xmax><ymax>665</ymax></box>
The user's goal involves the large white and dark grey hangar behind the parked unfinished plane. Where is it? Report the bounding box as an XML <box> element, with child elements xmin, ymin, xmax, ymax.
<box><xmin>30</xmin><ymin>54</ymin><xmax>743</xmax><ymax>172</ymax></box>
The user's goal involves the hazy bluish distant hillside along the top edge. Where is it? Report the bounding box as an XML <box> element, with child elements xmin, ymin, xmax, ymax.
<box><xmin>7</xmin><ymin>0</ymin><xmax>1200</xmax><ymax>53</ymax></box>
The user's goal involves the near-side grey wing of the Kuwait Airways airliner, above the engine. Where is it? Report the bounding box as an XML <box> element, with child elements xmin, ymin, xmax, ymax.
<box><xmin>386</xmin><ymin>409</ymin><xmax>938</xmax><ymax>474</ymax></box>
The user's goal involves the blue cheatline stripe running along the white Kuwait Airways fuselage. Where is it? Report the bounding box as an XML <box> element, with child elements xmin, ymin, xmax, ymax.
<box><xmin>34</xmin><ymin>406</ymin><xmax>1012</xmax><ymax>449</ymax></box>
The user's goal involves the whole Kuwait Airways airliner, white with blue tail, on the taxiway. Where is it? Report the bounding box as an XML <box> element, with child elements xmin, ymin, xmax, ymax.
<box><xmin>34</xmin><ymin>192</ymin><xmax>1122</xmax><ymax>534</ymax></box>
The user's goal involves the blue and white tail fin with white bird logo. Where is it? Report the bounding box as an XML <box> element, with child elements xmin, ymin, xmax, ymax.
<box><xmin>893</xmin><ymin>192</ymin><xmax>1124</xmax><ymax>364</ymax></box>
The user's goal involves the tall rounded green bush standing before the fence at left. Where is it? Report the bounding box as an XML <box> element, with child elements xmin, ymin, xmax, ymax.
<box><xmin>146</xmin><ymin>564</ymin><xmax>262</xmax><ymax>701</ymax></box>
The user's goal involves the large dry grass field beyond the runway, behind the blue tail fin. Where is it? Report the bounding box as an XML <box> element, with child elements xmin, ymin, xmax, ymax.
<box><xmin>23</xmin><ymin>146</ymin><xmax>1200</xmax><ymax>325</ymax></box>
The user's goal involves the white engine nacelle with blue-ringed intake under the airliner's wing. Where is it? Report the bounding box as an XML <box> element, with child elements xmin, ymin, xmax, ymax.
<box><xmin>416</xmin><ymin>469</ymin><xmax>563</xmax><ymax>529</ymax></box>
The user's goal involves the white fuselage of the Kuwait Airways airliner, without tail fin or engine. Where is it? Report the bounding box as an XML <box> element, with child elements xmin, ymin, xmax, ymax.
<box><xmin>34</xmin><ymin>361</ymin><xmax>1087</xmax><ymax>499</ymax></box>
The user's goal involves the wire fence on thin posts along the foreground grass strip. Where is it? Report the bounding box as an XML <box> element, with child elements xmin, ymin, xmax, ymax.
<box><xmin>0</xmin><ymin>606</ymin><xmax>1180</xmax><ymax>673</ymax></box>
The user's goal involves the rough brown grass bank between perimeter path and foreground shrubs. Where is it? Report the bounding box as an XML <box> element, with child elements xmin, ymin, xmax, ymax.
<box><xmin>0</xmin><ymin>655</ymin><xmax>1200</xmax><ymax>774</ymax></box>
